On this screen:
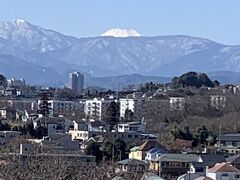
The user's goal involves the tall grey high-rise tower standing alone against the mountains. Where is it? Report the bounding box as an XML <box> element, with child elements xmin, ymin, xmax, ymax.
<box><xmin>69</xmin><ymin>72</ymin><xmax>84</xmax><ymax>95</ymax></box>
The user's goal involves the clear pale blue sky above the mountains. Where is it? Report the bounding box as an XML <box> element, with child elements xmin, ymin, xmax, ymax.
<box><xmin>0</xmin><ymin>0</ymin><xmax>240</xmax><ymax>44</ymax></box>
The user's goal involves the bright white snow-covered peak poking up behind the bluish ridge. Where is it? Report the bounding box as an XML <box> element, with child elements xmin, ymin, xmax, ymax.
<box><xmin>101</xmin><ymin>28</ymin><xmax>141</xmax><ymax>37</ymax></box>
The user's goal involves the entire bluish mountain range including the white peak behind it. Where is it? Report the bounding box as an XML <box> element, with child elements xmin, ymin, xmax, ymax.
<box><xmin>0</xmin><ymin>19</ymin><xmax>240</xmax><ymax>87</ymax></box>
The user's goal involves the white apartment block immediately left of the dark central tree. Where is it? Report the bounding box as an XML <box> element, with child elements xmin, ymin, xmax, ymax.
<box><xmin>84</xmin><ymin>98</ymin><xmax>112</xmax><ymax>120</ymax></box>
